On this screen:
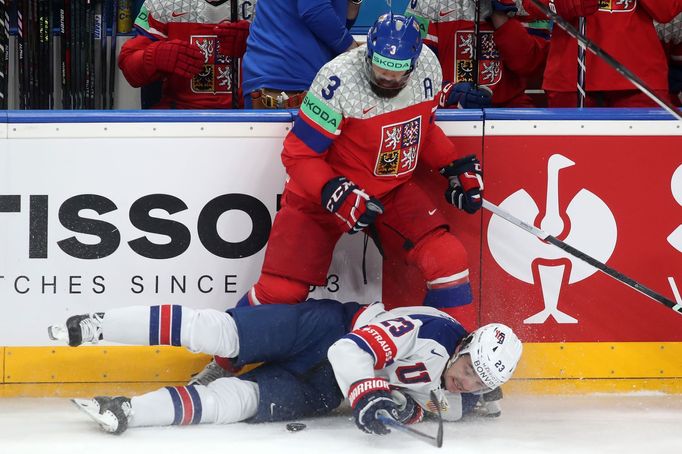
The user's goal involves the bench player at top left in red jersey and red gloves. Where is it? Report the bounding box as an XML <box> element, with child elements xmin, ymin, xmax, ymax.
<box><xmin>118</xmin><ymin>0</ymin><xmax>256</xmax><ymax>109</ymax></box>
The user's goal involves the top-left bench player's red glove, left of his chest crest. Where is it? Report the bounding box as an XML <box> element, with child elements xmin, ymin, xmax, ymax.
<box><xmin>143</xmin><ymin>39</ymin><xmax>204</xmax><ymax>79</ymax></box>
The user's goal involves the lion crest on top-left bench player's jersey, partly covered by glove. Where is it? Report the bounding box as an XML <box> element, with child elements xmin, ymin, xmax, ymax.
<box><xmin>190</xmin><ymin>35</ymin><xmax>232</xmax><ymax>93</ymax></box>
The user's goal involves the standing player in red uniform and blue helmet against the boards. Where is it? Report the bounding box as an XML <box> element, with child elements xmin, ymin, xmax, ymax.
<box><xmin>238</xmin><ymin>14</ymin><xmax>483</xmax><ymax>322</ymax></box>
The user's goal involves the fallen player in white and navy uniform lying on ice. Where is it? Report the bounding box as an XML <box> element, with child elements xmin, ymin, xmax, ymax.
<box><xmin>49</xmin><ymin>299</ymin><xmax>522</xmax><ymax>434</ymax></box>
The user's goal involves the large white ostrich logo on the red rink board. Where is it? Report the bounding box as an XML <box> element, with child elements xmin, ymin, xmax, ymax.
<box><xmin>487</xmin><ymin>154</ymin><xmax>617</xmax><ymax>324</ymax></box>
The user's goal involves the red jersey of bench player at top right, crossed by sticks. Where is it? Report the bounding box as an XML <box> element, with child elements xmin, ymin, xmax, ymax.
<box><xmin>527</xmin><ymin>0</ymin><xmax>682</xmax><ymax>92</ymax></box>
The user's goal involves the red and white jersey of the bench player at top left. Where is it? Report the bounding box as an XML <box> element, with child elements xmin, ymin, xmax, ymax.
<box><xmin>119</xmin><ymin>0</ymin><xmax>256</xmax><ymax>109</ymax></box>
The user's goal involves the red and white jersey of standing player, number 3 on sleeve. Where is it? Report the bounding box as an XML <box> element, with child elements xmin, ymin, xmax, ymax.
<box><xmin>282</xmin><ymin>46</ymin><xmax>458</xmax><ymax>203</ymax></box>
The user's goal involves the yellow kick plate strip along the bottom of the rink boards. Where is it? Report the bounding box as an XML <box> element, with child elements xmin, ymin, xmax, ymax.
<box><xmin>0</xmin><ymin>342</ymin><xmax>682</xmax><ymax>397</ymax></box>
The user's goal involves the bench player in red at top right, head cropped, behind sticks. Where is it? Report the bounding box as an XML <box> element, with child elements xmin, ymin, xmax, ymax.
<box><xmin>526</xmin><ymin>0</ymin><xmax>682</xmax><ymax>107</ymax></box>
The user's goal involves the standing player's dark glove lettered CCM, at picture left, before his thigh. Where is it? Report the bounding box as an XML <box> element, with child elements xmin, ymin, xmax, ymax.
<box><xmin>322</xmin><ymin>177</ymin><xmax>384</xmax><ymax>235</ymax></box>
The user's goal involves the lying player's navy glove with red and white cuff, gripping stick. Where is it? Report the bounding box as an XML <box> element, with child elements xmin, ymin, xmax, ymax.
<box><xmin>348</xmin><ymin>378</ymin><xmax>400</xmax><ymax>435</ymax></box>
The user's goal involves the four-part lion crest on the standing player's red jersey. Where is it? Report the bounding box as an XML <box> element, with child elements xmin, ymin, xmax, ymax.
<box><xmin>374</xmin><ymin>116</ymin><xmax>421</xmax><ymax>176</ymax></box>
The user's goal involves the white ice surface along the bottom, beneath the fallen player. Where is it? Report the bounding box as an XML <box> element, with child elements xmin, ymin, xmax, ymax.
<box><xmin>0</xmin><ymin>393</ymin><xmax>682</xmax><ymax>454</ymax></box>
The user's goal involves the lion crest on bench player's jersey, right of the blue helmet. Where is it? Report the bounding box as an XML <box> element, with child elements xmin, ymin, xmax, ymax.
<box><xmin>455</xmin><ymin>30</ymin><xmax>502</xmax><ymax>85</ymax></box>
